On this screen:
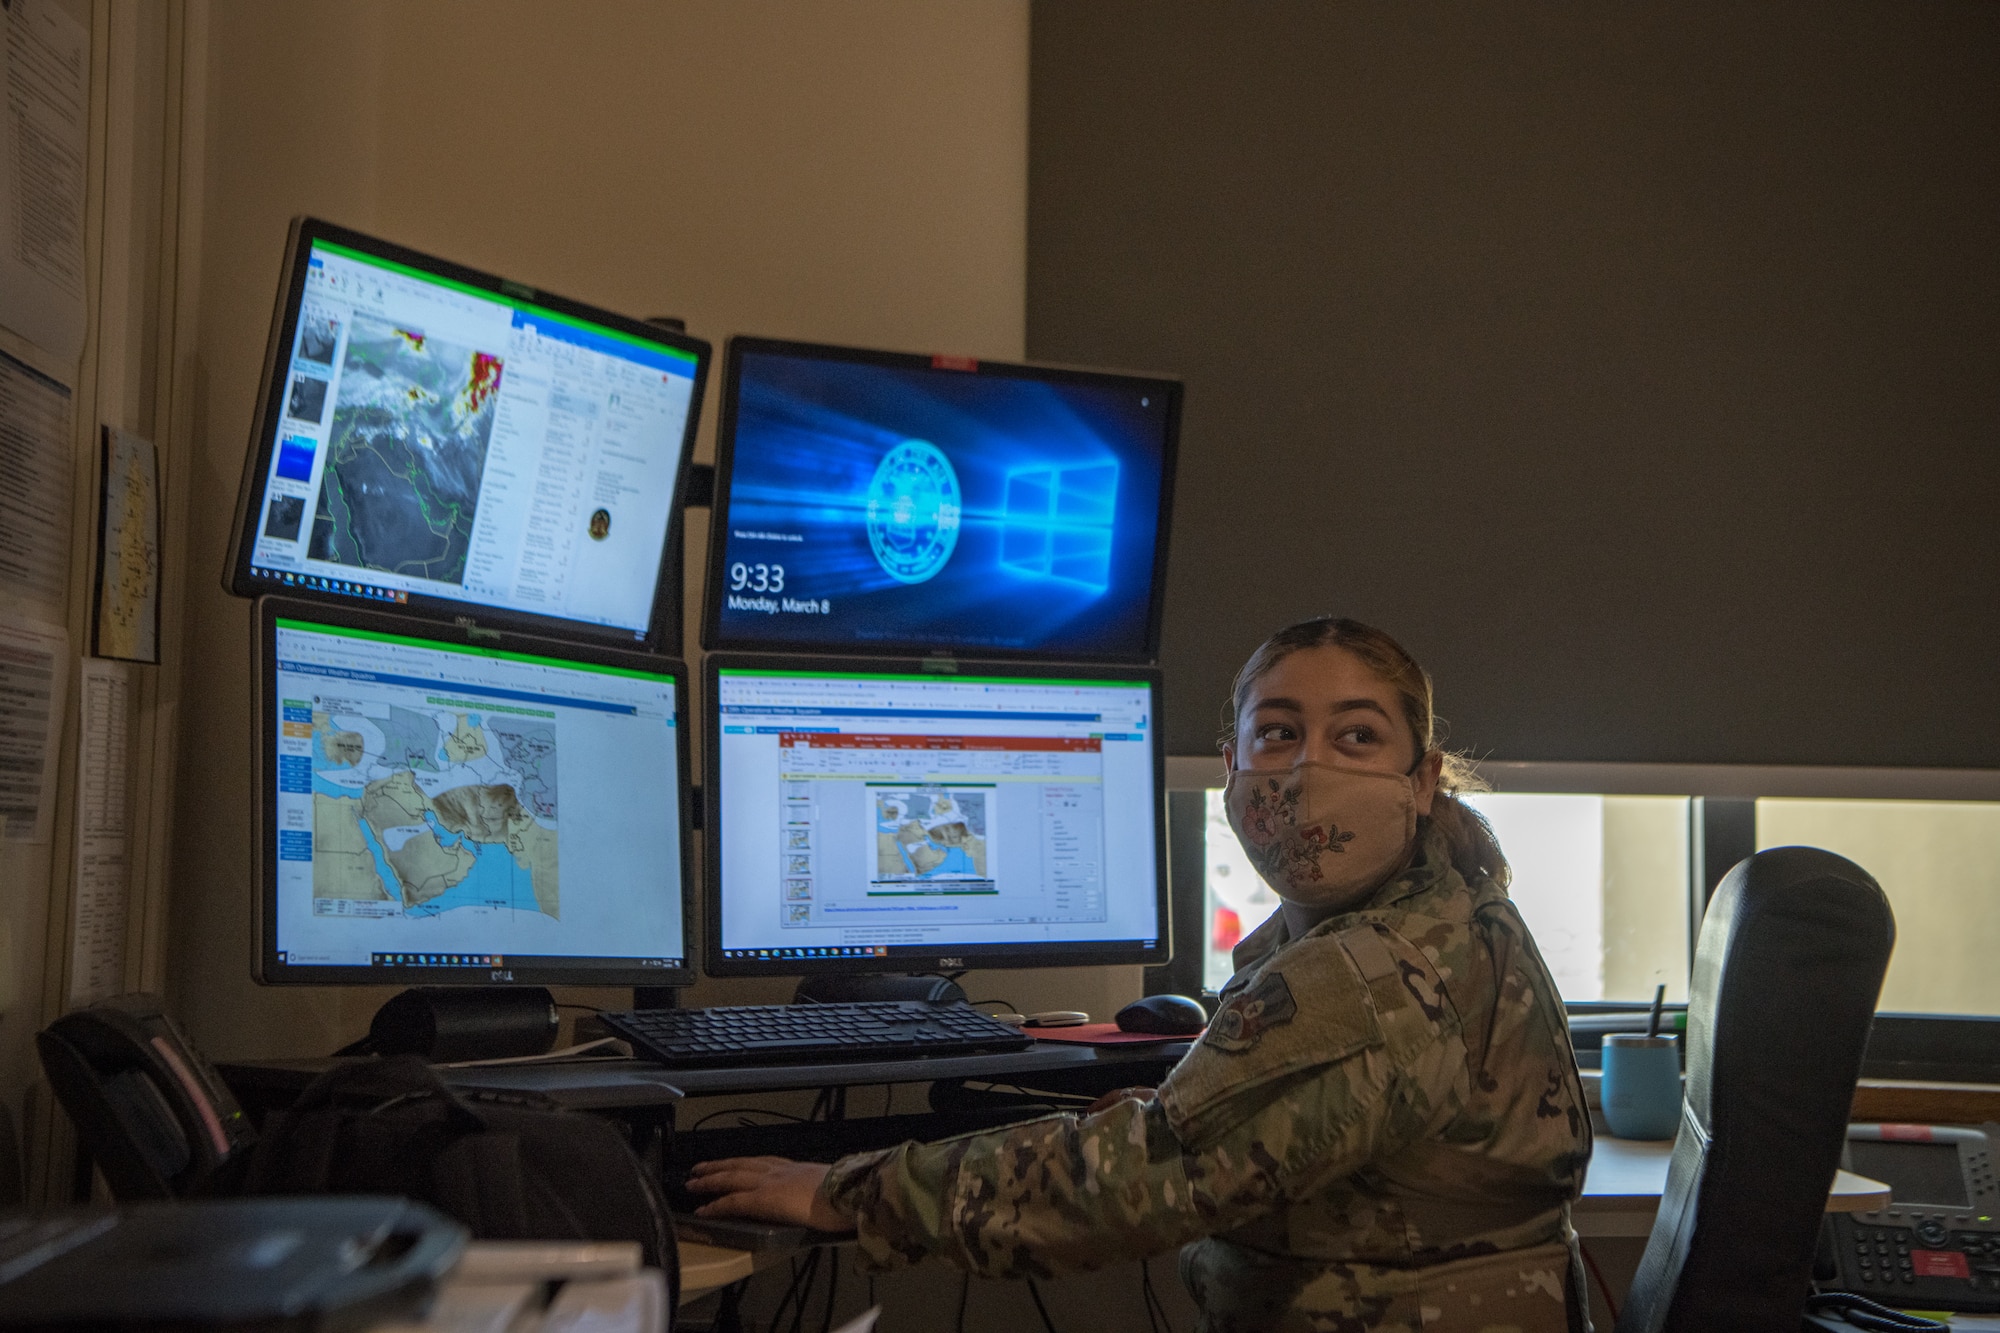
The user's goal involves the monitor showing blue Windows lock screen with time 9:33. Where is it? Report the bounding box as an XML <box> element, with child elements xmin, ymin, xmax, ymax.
<box><xmin>704</xmin><ymin>338</ymin><xmax>1180</xmax><ymax>662</ymax></box>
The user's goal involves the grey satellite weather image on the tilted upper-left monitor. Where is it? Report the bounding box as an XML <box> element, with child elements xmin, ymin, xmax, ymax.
<box><xmin>308</xmin><ymin>314</ymin><xmax>502</xmax><ymax>582</ymax></box>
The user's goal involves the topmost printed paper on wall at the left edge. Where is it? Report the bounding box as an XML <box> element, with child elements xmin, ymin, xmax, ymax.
<box><xmin>0</xmin><ymin>0</ymin><xmax>90</xmax><ymax>364</ymax></box>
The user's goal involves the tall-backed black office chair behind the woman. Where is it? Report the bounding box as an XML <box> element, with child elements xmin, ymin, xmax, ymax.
<box><xmin>1618</xmin><ymin>847</ymin><xmax>1896</xmax><ymax>1333</ymax></box>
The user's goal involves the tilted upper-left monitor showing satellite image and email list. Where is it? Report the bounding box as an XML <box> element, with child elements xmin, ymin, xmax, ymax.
<box><xmin>224</xmin><ymin>218</ymin><xmax>710</xmax><ymax>654</ymax></box>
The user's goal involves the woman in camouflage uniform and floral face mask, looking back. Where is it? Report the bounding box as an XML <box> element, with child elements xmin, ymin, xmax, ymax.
<box><xmin>692</xmin><ymin>618</ymin><xmax>1590</xmax><ymax>1333</ymax></box>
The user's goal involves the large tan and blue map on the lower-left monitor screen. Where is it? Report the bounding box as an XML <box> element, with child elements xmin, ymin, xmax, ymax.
<box><xmin>312</xmin><ymin>701</ymin><xmax>562</xmax><ymax>921</ymax></box>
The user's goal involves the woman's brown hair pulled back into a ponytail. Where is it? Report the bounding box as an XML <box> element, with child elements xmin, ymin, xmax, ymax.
<box><xmin>1222</xmin><ymin>616</ymin><xmax>1514</xmax><ymax>889</ymax></box>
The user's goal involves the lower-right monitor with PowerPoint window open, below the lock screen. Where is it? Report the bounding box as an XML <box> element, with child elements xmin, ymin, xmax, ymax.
<box><xmin>704</xmin><ymin>654</ymin><xmax>1168</xmax><ymax>977</ymax></box>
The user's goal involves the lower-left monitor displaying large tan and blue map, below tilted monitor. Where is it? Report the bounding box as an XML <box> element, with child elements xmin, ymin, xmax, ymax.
<box><xmin>256</xmin><ymin>598</ymin><xmax>694</xmax><ymax>987</ymax></box>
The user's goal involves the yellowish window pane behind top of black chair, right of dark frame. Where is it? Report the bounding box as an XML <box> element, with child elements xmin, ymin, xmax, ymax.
<box><xmin>1756</xmin><ymin>797</ymin><xmax>2000</xmax><ymax>1015</ymax></box>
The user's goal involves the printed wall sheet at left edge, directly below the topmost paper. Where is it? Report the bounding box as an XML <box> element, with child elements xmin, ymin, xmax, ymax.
<box><xmin>0</xmin><ymin>342</ymin><xmax>74</xmax><ymax>620</ymax></box>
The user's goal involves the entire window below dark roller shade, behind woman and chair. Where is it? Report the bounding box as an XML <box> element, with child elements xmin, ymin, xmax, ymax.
<box><xmin>1188</xmin><ymin>765</ymin><xmax>2000</xmax><ymax>1024</ymax></box>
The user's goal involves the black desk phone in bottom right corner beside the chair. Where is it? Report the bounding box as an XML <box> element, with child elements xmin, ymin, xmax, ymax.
<box><xmin>1820</xmin><ymin>1125</ymin><xmax>2000</xmax><ymax>1311</ymax></box>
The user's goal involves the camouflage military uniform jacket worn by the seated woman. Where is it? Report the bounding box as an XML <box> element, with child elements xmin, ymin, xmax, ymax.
<box><xmin>822</xmin><ymin>821</ymin><xmax>1590</xmax><ymax>1333</ymax></box>
